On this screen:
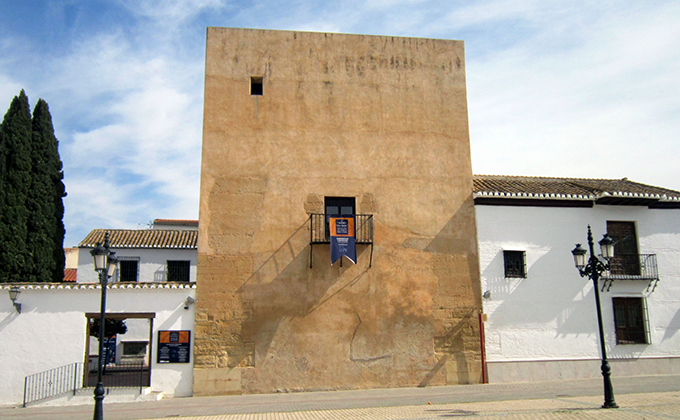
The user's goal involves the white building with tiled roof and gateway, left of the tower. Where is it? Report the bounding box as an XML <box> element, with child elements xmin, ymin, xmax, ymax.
<box><xmin>0</xmin><ymin>219</ymin><xmax>198</xmax><ymax>405</ymax></box>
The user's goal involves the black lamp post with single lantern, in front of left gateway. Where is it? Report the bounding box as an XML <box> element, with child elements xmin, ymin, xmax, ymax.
<box><xmin>90</xmin><ymin>232</ymin><xmax>118</xmax><ymax>420</ymax></box>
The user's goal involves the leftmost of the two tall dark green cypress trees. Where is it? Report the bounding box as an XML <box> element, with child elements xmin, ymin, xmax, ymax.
<box><xmin>0</xmin><ymin>90</ymin><xmax>33</xmax><ymax>282</ymax></box>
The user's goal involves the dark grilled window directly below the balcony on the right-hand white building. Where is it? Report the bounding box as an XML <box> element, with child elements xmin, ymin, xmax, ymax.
<box><xmin>612</xmin><ymin>297</ymin><xmax>649</xmax><ymax>344</ymax></box>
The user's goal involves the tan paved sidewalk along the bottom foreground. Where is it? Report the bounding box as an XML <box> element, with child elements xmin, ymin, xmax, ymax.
<box><xmin>0</xmin><ymin>375</ymin><xmax>680</xmax><ymax>420</ymax></box>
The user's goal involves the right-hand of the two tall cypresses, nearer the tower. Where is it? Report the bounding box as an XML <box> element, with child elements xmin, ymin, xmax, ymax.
<box><xmin>27</xmin><ymin>99</ymin><xmax>66</xmax><ymax>282</ymax></box>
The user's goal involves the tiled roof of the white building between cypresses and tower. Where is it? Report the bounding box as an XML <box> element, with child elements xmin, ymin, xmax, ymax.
<box><xmin>78</xmin><ymin>229</ymin><xmax>198</xmax><ymax>249</ymax></box>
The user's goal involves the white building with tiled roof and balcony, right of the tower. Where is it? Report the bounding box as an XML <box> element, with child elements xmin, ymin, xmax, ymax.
<box><xmin>474</xmin><ymin>175</ymin><xmax>680</xmax><ymax>383</ymax></box>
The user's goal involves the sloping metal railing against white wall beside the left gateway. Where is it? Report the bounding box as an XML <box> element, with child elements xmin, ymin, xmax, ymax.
<box><xmin>23</xmin><ymin>363</ymin><xmax>83</xmax><ymax>407</ymax></box>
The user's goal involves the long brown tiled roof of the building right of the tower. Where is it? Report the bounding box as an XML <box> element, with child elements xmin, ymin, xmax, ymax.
<box><xmin>473</xmin><ymin>175</ymin><xmax>680</xmax><ymax>203</ymax></box>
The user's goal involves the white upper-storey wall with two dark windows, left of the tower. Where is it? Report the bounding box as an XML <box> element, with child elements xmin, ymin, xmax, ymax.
<box><xmin>78</xmin><ymin>248</ymin><xmax>198</xmax><ymax>283</ymax></box>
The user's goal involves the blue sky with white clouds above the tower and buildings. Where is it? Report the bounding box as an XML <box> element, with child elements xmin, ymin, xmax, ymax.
<box><xmin>0</xmin><ymin>0</ymin><xmax>680</xmax><ymax>246</ymax></box>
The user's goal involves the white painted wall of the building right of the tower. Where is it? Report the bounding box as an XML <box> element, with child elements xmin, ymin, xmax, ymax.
<box><xmin>475</xmin><ymin>205</ymin><xmax>680</xmax><ymax>382</ymax></box>
